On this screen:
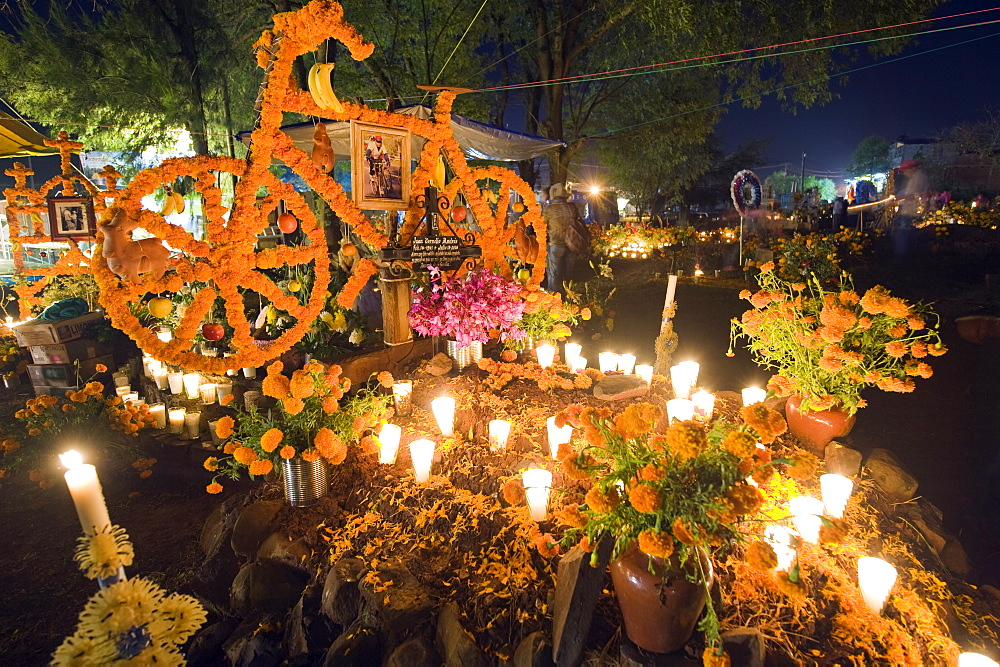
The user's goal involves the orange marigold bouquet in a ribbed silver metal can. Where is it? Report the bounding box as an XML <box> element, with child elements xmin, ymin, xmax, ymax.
<box><xmin>204</xmin><ymin>360</ymin><xmax>389</xmax><ymax>506</ymax></box>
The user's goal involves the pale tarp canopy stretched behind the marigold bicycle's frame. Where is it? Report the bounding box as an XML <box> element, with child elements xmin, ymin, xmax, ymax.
<box><xmin>236</xmin><ymin>104</ymin><xmax>563</xmax><ymax>162</ymax></box>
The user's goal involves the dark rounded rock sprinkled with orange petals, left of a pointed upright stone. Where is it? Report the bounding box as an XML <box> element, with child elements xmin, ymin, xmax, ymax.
<box><xmin>358</xmin><ymin>563</ymin><xmax>434</xmax><ymax>649</ymax></box>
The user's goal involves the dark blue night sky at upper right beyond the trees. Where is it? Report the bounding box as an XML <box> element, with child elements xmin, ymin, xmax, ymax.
<box><xmin>718</xmin><ymin>0</ymin><xmax>1000</xmax><ymax>180</ymax></box>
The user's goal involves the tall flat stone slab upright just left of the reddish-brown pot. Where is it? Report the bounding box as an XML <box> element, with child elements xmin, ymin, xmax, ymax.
<box><xmin>552</xmin><ymin>539</ymin><xmax>612</xmax><ymax>667</ymax></box>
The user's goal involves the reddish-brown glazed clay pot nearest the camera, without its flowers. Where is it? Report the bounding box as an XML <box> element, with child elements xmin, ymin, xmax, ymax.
<box><xmin>611</xmin><ymin>545</ymin><xmax>713</xmax><ymax>653</ymax></box>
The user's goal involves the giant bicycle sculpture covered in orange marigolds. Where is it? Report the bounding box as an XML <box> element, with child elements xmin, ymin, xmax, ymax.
<box><xmin>93</xmin><ymin>0</ymin><xmax>545</xmax><ymax>373</ymax></box>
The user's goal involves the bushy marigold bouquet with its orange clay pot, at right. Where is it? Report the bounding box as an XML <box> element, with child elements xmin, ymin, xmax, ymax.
<box><xmin>728</xmin><ymin>262</ymin><xmax>947</xmax><ymax>453</ymax></box>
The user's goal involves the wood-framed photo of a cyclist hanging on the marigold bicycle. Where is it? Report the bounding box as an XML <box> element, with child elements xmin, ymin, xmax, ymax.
<box><xmin>351</xmin><ymin>121</ymin><xmax>410</xmax><ymax>211</ymax></box>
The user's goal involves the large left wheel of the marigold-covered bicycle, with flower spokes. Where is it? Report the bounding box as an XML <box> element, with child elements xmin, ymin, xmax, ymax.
<box><xmin>93</xmin><ymin>156</ymin><xmax>330</xmax><ymax>373</ymax></box>
